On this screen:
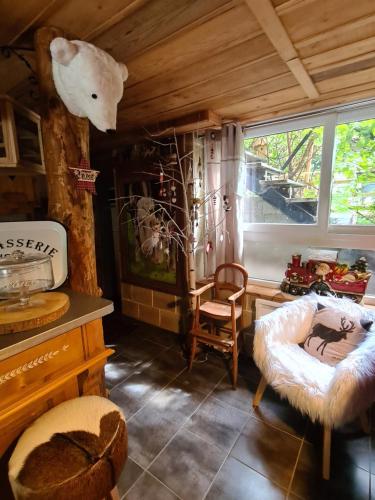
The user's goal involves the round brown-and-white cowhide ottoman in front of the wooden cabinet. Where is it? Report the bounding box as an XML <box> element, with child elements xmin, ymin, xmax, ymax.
<box><xmin>9</xmin><ymin>396</ymin><xmax>128</xmax><ymax>500</ymax></box>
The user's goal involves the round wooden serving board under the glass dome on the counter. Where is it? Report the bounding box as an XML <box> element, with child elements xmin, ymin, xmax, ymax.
<box><xmin>0</xmin><ymin>292</ymin><xmax>70</xmax><ymax>335</ymax></box>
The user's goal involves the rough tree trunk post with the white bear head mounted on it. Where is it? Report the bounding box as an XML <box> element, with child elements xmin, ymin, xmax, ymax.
<box><xmin>34</xmin><ymin>27</ymin><xmax>101</xmax><ymax>296</ymax></box>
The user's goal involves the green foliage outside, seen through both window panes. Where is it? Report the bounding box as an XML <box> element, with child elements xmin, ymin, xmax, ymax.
<box><xmin>245</xmin><ymin>119</ymin><xmax>375</xmax><ymax>225</ymax></box>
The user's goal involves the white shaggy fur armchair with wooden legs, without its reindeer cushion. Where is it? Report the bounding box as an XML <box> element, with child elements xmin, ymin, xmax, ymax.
<box><xmin>253</xmin><ymin>295</ymin><xmax>375</xmax><ymax>479</ymax></box>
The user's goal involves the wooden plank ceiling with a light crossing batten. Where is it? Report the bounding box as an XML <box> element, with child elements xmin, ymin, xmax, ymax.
<box><xmin>0</xmin><ymin>0</ymin><xmax>375</xmax><ymax>145</ymax></box>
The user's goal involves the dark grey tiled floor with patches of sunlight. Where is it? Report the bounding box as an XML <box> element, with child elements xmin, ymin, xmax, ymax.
<box><xmin>105</xmin><ymin>316</ymin><xmax>375</xmax><ymax>500</ymax></box>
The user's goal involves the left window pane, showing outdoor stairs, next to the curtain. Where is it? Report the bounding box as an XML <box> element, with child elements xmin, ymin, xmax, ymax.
<box><xmin>244</xmin><ymin>127</ymin><xmax>323</xmax><ymax>224</ymax></box>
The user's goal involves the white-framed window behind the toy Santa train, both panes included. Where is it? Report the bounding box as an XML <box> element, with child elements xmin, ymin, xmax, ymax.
<box><xmin>244</xmin><ymin>106</ymin><xmax>375</xmax><ymax>295</ymax></box>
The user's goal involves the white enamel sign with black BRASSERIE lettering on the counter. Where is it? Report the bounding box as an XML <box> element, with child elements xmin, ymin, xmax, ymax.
<box><xmin>0</xmin><ymin>221</ymin><xmax>68</xmax><ymax>288</ymax></box>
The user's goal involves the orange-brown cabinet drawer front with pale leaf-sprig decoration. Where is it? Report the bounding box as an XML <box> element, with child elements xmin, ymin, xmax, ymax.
<box><xmin>0</xmin><ymin>328</ymin><xmax>85</xmax><ymax>411</ymax></box>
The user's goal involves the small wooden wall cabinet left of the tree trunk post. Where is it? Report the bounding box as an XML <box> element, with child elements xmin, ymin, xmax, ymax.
<box><xmin>0</xmin><ymin>96</ymin><xmax>45</xmax><ymax>175</ymax></box>
